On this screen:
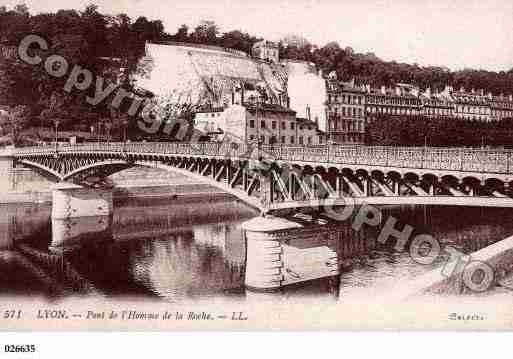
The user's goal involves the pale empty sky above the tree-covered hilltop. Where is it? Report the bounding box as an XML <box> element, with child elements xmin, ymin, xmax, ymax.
<box><xmin>4</xmin><ymin>0</ymin><xmax>513</xmax><ymax>71</ymax></box>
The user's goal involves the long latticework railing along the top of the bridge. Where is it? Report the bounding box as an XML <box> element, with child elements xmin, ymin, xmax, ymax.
<box><xmin>10</xmin><ymin>142</ymin><xmax>513</xmax><ymax>174</ymax></box>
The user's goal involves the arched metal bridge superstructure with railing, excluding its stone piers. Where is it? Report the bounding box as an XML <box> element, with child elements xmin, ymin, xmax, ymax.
<box><xmin>9</xmin><ymin>143</ymin><xmax>513</xmax><ymax>210</ymax></box>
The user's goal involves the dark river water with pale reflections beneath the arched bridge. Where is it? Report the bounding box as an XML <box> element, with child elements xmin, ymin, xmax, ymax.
<box><xmin>0</xmin><ymin>198</ymin><xmax>513</xmax><ymax>302</ymax></box>
